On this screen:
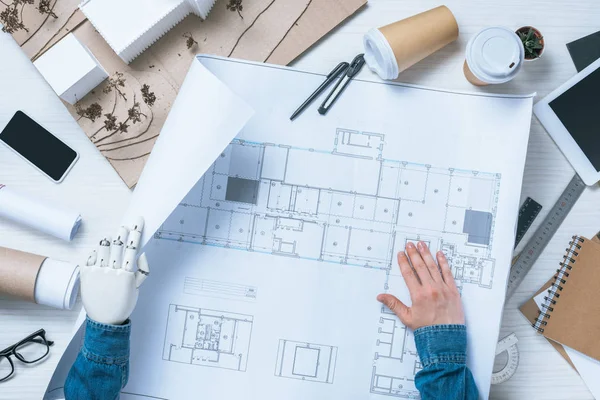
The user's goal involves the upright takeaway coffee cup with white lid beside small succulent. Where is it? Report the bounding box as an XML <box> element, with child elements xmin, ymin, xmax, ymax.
<box><xmin>463</xmin><ymin>27</ymin><xmax>525</xmax><ymax>86</ymax></box>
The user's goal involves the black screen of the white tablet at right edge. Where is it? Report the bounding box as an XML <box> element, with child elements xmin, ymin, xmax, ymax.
<box><xmin>550</xmin><ymin>68</ymin><xmax>600</xmax><ymax>172</ymax></box>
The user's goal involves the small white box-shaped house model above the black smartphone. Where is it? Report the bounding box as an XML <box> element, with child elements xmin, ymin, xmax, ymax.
<box><xmin>33</xmin><ymin>33</ymin><xmax>108</xmax><ymax>104</ymax></box>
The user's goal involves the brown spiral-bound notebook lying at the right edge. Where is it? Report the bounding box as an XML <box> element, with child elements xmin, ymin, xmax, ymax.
<box><xmin>522</xmin><ymin>237</ymin><xmax>600</xmax><ymax>360</ymax></box>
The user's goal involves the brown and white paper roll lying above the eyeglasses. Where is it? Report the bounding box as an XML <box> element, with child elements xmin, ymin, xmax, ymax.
<box><xmin>0</xmin><ymin>247</ymin><xmax>79</xmax><ymax>310</ymax></box>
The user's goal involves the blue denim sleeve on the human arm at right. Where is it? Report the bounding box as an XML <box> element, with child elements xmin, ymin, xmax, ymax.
<box><xmin>414</xmin><ymin>325</ymin><xmax>479</xmax><ymax>400</ymax></box>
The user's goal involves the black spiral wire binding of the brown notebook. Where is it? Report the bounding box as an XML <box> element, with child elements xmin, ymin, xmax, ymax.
<box><xmin>532</xmin><ymin>236</ymin><xmax>585</xmax><ymax>333</ymax></box>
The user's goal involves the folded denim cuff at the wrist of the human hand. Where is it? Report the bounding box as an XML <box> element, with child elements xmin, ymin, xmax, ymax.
<box><xmin>414</xmin><ymin>325</ymin><xmax>467</xmax><ymax>367</ymax></box>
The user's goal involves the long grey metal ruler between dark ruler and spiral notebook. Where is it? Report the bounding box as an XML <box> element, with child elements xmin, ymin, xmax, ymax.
<box><xmin>506</xmin><ymin>175</ymin><xmax>586</xmax><ymax>300</ymax></box>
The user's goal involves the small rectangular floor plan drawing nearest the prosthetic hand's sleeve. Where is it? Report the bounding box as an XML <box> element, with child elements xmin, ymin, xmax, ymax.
<box><xmin>163</xmin><ymin>304</ymin><xmax>254</xmax><ymax>371</ymax></box>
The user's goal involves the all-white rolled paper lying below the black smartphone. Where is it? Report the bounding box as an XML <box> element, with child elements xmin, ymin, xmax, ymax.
<box><xmin>0</xmin><ymin>184</ymin><xmax>81</xmax><ymax>241</ymax></box>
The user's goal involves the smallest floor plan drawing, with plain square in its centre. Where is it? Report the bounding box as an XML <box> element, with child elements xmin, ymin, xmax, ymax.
<box><xmin>275</xmin><ymin>339</ymin><xmax>338</xmax><ymax>383</ymax></box>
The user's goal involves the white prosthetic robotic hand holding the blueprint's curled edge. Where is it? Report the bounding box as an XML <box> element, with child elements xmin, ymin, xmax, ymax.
<box><xmin>81</xmin><ymin>218</ymin><xmax>149</xmax><ymax>325</ymax></box>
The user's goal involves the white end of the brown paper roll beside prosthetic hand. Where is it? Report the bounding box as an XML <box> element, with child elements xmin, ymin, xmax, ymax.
<box><xmin>35</xmin><ymin>258</ymin><xmax>79</xmax><ymax>310</ymax></box>
